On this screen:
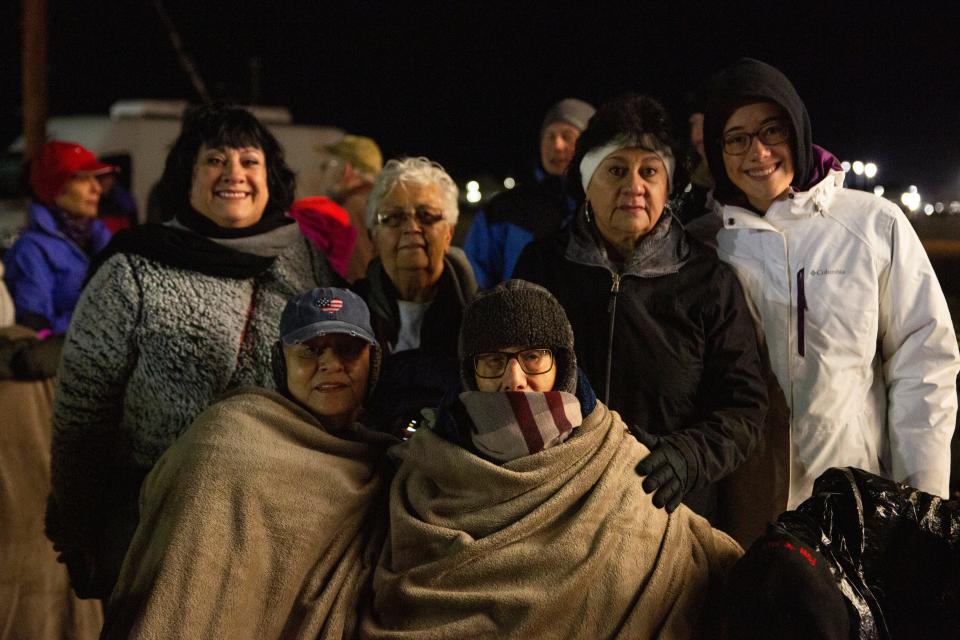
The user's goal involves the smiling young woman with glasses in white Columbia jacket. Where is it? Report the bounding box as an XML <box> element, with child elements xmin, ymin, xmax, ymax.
<box><xmin>704</xmin><ymin>59</ymin><xmax>960</xmax><ymax>509</ymax></box>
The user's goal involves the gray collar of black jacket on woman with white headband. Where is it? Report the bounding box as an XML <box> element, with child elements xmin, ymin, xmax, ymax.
<box><xmin>565</xmin><ymin>205</ymin><xmax>690</xmax><ymax>278</ymax></box>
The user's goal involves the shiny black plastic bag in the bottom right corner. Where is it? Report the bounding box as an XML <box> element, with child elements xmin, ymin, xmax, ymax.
<box><xmin>788</xmin><ymin>467</ymin><xmax>960</xmax><ymax>640</ymax></box>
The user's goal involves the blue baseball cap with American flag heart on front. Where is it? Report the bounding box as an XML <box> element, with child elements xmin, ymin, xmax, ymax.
<box><xmin>280</xmin><ymin>287</ymin><xmax>377</xmax><ymax>345</ymax></box>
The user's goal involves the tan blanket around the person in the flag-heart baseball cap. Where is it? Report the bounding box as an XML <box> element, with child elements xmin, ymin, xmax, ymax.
<box><xmin>104</xmin><ymin>388</ymin><xmax>395</xmax><ymax>640</ymax></box>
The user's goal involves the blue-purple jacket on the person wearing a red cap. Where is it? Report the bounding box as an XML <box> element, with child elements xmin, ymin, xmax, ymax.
<box><xmin>3</xmin><ymin>202</ymin><xmax>110</xmax><ymax>333</ymax></box>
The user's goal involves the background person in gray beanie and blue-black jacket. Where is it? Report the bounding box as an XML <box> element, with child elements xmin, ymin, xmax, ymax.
<box><xmin>464</xmin><ymin>98</ymin><xmax>594</xmax><ymax>289</ymax></box>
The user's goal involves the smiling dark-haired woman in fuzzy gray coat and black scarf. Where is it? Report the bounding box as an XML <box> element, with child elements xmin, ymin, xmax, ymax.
<box><xmin>47</xmin><ymin>106</ymin><xmax>335</xmax><ymax>598</ymax></box>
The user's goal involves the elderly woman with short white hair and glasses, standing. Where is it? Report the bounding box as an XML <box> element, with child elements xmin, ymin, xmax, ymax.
<box><xmin>354</xmin><ymin>158</ymin><xmax>477</xmax><ymax>435</ymax></box>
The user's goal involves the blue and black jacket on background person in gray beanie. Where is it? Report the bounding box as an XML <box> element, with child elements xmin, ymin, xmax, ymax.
<box><xmin>463</xmin><ymin>170</ymin><xmax>576</xmax><ymax>289</ymax></box>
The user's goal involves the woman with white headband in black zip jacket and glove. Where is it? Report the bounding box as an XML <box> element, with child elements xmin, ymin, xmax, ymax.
<box><xmin>514</xmin><ymin>96</ymin><xmax>767</xmax><ymax>533</ymax></box>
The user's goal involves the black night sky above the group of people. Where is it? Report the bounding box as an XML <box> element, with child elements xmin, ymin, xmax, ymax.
<box><xmin>0</xmin><ymin>0</ymin><xmax>960</xmax><ymax>197</ymax></box>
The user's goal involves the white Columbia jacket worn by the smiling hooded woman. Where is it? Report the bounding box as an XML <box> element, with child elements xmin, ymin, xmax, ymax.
<box><xmin>715</xmin><ymin>171</ymin><xmax>960</xmax><ymax>509</ymax></box>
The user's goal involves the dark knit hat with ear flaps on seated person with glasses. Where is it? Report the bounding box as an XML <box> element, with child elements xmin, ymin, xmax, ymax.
<box><xmin>459</xmin><ymin>280</ymin><xmax>577</xmax><ymax>393</ymax></box>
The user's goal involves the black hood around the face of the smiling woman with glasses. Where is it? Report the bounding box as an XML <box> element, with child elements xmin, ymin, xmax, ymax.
<box><xmin>703</xmin><ymin>58</ymin><xmax>822</xmax><ymax>204</ymax></box>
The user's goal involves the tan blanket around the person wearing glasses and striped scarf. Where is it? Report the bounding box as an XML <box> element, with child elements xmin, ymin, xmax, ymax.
<box><xmin>361</xmin><ymin>404</ymin><xmax>743</xmax><ymax>640</ymax></box>
